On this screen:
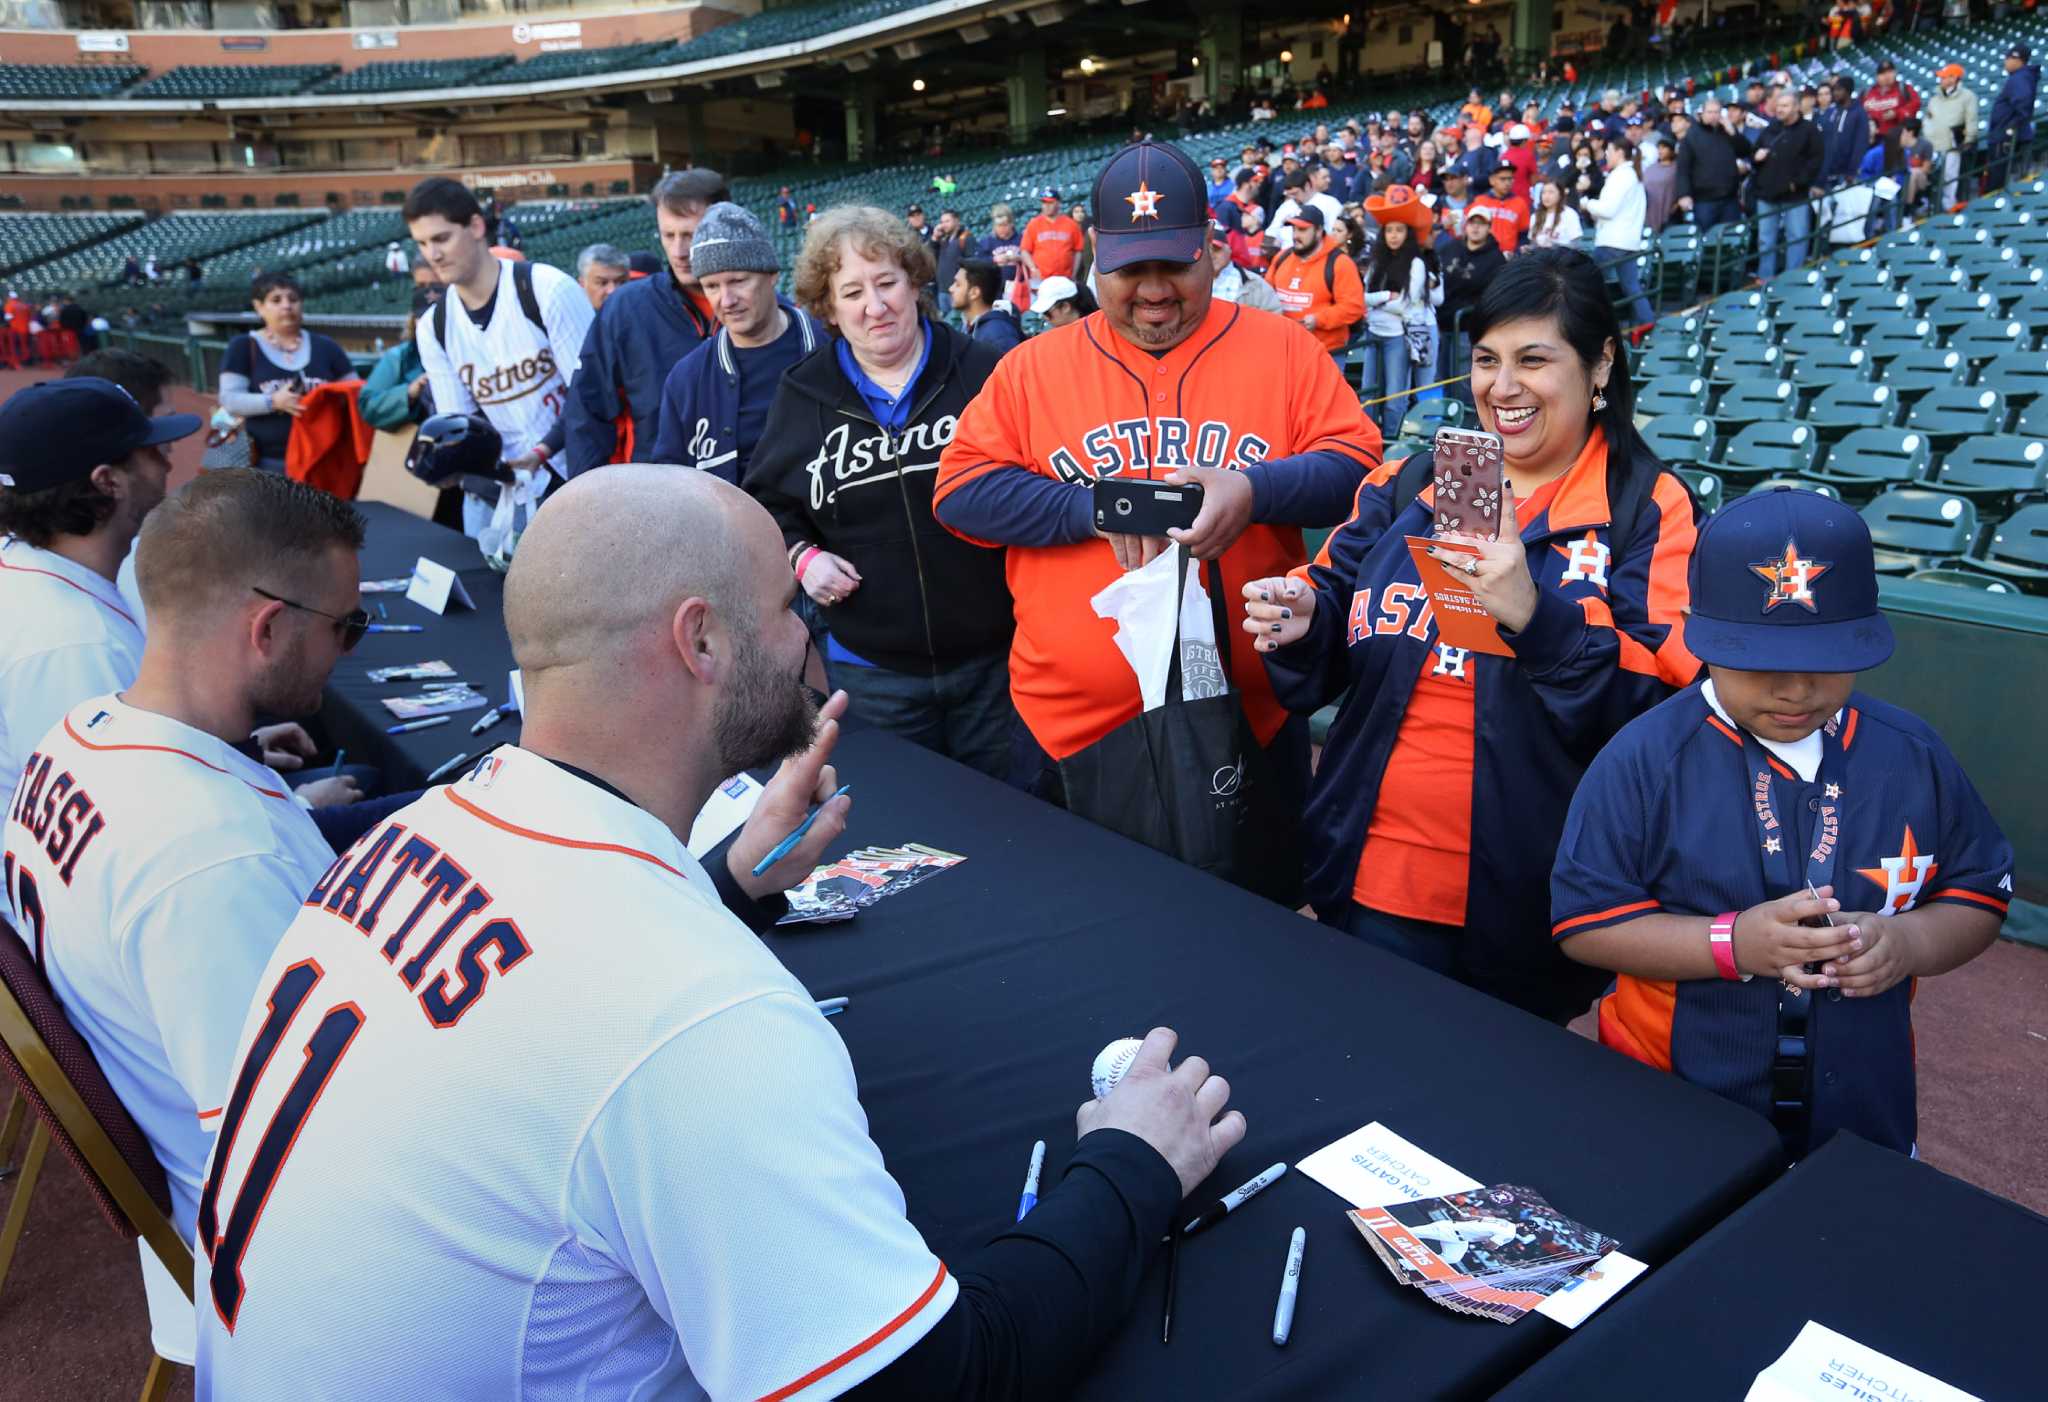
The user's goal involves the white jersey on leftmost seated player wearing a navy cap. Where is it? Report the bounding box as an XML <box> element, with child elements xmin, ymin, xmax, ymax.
<box><xmin>0</xmin><ymin>536</ymin><xmax>141</xmax><ymax>818</ymax></box>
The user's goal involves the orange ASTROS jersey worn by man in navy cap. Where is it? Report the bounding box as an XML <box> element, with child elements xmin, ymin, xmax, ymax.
<box><xmin>932</xmin><ymin>301</ymin><xmax>1380</xmax><ymax>759</ymax></box>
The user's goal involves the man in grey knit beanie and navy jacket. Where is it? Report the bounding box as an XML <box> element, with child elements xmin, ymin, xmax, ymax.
<box><xmin>635</xmin><ymin>205</ymin><xmax>825</xmax><ymax>485</ymax></box>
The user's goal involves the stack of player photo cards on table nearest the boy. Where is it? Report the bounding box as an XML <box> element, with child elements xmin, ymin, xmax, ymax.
<box><xmin>1346</xmin><ymin>1183</ymin><xmax>1620</xmax><ymax>1324</ymax></box>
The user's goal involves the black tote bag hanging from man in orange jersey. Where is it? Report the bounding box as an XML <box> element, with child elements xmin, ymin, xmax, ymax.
<box><xmin>1059</xmin><ymin>553</ymin><xmax>1300</xmax><ymax>909</ymax></box>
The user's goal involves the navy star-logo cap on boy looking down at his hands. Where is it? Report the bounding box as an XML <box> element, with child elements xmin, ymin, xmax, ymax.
<box><xmin>1686</xmin><ymin>487</ymin><xmax>1892</xmax><ymax>671</ymax></box>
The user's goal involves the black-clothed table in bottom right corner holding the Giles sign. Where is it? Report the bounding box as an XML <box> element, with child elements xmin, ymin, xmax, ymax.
<box><xmin>1501</xmin><ymin>1134</ymin><xmax>2048</xmax><ymax>1402</ymax></box>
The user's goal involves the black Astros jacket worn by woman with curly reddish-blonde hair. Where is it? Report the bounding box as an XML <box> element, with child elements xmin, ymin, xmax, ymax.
<box><xmin>741</xmin><ymin>321</ymin><xmax>1016</xmax><ymax>673</ymax></box>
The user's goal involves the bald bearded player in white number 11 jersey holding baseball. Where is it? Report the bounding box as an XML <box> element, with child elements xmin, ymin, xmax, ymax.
<box><xmin>199</xmin><ymin>465</ymin><xmax>1245</xmax><ymax>1400</ymax></box>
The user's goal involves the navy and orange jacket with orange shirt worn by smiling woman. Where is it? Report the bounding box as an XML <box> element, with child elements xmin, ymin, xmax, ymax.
<box><xmin>1266</xmin><ymin>432</ymin><xmax>1698</xmax><ymax>998</ymax></box>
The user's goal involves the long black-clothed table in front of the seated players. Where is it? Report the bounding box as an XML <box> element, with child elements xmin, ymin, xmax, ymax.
<box><xmin>326</xmin><ymin>499</ymin><xmax>1778</xmax><ymax>1400</ymax></box>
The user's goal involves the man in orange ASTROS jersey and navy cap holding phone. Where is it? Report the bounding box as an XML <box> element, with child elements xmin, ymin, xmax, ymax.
<box><xmin>932</xmin><ymin>141</ymin><xmax>1380</xmax><ymax>843</ymax></box>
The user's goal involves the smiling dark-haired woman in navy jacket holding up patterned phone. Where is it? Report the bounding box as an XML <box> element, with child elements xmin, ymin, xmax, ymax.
<box><xmin>1243</xmin><ymin>248</ymin><xmax>1698</xmax><ymax>1021</ymax></box>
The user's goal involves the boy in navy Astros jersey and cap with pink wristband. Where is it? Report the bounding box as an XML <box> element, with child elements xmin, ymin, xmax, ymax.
<box><xmin>1550</xmin><ymin>489</ymin><xmax>2013</xmax><ymax>1158</ymax></box>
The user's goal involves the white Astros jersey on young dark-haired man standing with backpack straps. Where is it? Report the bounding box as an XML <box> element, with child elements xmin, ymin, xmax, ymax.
<box><xmin>414</xmin><ymin>260</ymin><xmax>592</xmax><ymax>458</ymax></box>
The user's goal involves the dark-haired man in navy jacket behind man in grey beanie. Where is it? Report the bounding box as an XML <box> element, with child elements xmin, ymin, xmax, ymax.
<box><xmin>563</xmin><ymin>170</ymin><xmax>729</xmax><ymax>477</ymax></box>
